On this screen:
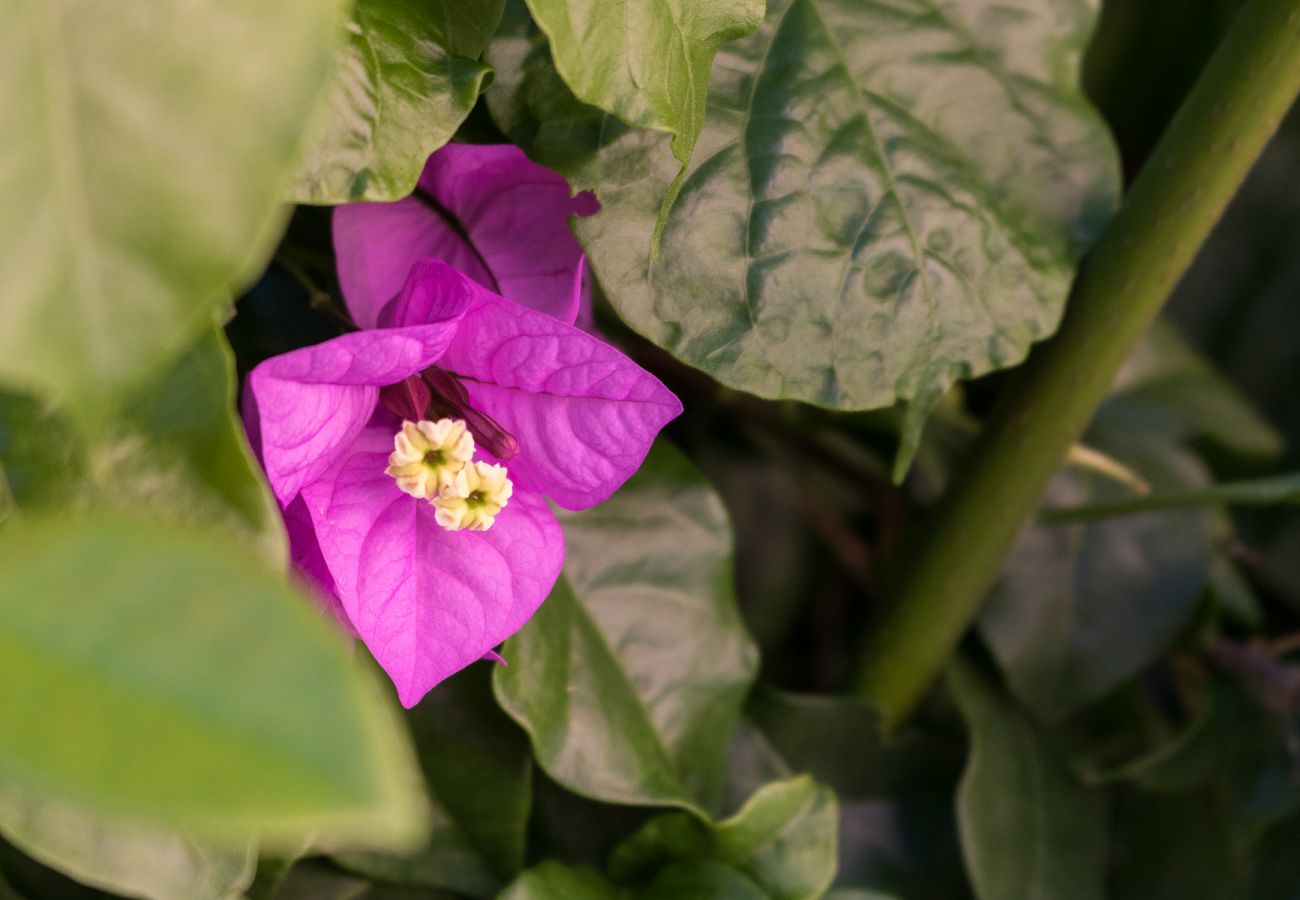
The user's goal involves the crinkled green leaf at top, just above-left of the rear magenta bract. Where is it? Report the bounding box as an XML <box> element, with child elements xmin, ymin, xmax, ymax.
<box><xmin>293</xmin><ymin>0</ymin><xmax>499</xmax><ymax>203</ymax></box>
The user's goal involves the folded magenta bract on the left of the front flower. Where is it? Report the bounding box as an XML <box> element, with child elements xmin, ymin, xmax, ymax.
<box><xmin>243</xmin><ymin>316</ymin><xmax>460</xmax><ymax>507</ymax></box>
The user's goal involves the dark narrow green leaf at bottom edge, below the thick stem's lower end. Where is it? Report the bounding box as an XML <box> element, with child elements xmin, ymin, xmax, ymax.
<box><xmin>949</xmin><ymin>661</ymin><xmax>1108</xmax><ymax>900</ymax></box>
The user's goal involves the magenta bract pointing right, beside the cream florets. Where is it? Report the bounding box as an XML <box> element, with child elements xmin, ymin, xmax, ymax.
<box><xmin>406</xmin><ymin>260</ymin><xmax>681</xmax><ymax>510</ymax></box>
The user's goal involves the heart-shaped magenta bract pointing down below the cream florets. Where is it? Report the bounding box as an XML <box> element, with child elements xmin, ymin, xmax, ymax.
<box><xmin>303</xmin><ymin>428</ymin><xmax>564</xmax><ymax>706</ymax></box>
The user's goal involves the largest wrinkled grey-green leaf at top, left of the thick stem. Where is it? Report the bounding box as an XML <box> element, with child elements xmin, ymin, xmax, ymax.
<box><xmin>488</xmin><ymin>0</ymin><xmax>1117</xmax><ymax>460</ymax></box>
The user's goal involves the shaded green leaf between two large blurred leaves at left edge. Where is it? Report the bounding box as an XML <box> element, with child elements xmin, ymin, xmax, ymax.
<box><xmin>0</xmin><ymin>330</ymin><xmax>287</xmax><ymax>566</ymax></box>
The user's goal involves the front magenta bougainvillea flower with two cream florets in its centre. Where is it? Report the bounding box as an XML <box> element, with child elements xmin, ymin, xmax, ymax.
<box><xmin>244</xmin><ymin>259</ymin><xmax>681</xmax><ymax>706</ymax></box>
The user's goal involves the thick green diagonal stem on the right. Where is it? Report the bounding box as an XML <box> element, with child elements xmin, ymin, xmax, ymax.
<box><xmin>857</xmin><ymin>0</ymin><xmax>1300</xmax><ymax>728</ymax></box>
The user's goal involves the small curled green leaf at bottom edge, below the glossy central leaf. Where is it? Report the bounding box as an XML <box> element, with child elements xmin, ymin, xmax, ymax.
<box><xmin>610</xmin><ymin>775</ymin><xmax>839</xmax><ymax>900</ymax></box>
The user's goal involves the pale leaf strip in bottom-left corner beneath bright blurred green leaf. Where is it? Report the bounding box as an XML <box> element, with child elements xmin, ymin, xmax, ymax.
<box><xmin>0</xmin><ymin>787</ymin><xmax>254</xmax><ymax>900</ymax></box>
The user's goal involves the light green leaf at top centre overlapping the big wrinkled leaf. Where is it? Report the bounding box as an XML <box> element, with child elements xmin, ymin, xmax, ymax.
<box><xmin>517</xmin><ymin>0</ymin><xmax>763</xmax><ymax>171</ymax></box>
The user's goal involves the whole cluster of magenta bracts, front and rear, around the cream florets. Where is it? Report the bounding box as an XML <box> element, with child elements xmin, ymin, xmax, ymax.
<box><xmin>244</xmin><ymin>146</ymin><xmax>681</xmax><ymax>706</ymax></box>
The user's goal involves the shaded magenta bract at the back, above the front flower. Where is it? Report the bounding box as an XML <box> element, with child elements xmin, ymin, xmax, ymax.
<box><xmin>334</xmin><ymin>144</ymin><xmax>599</xmax><ymax>328</ymax></box>
